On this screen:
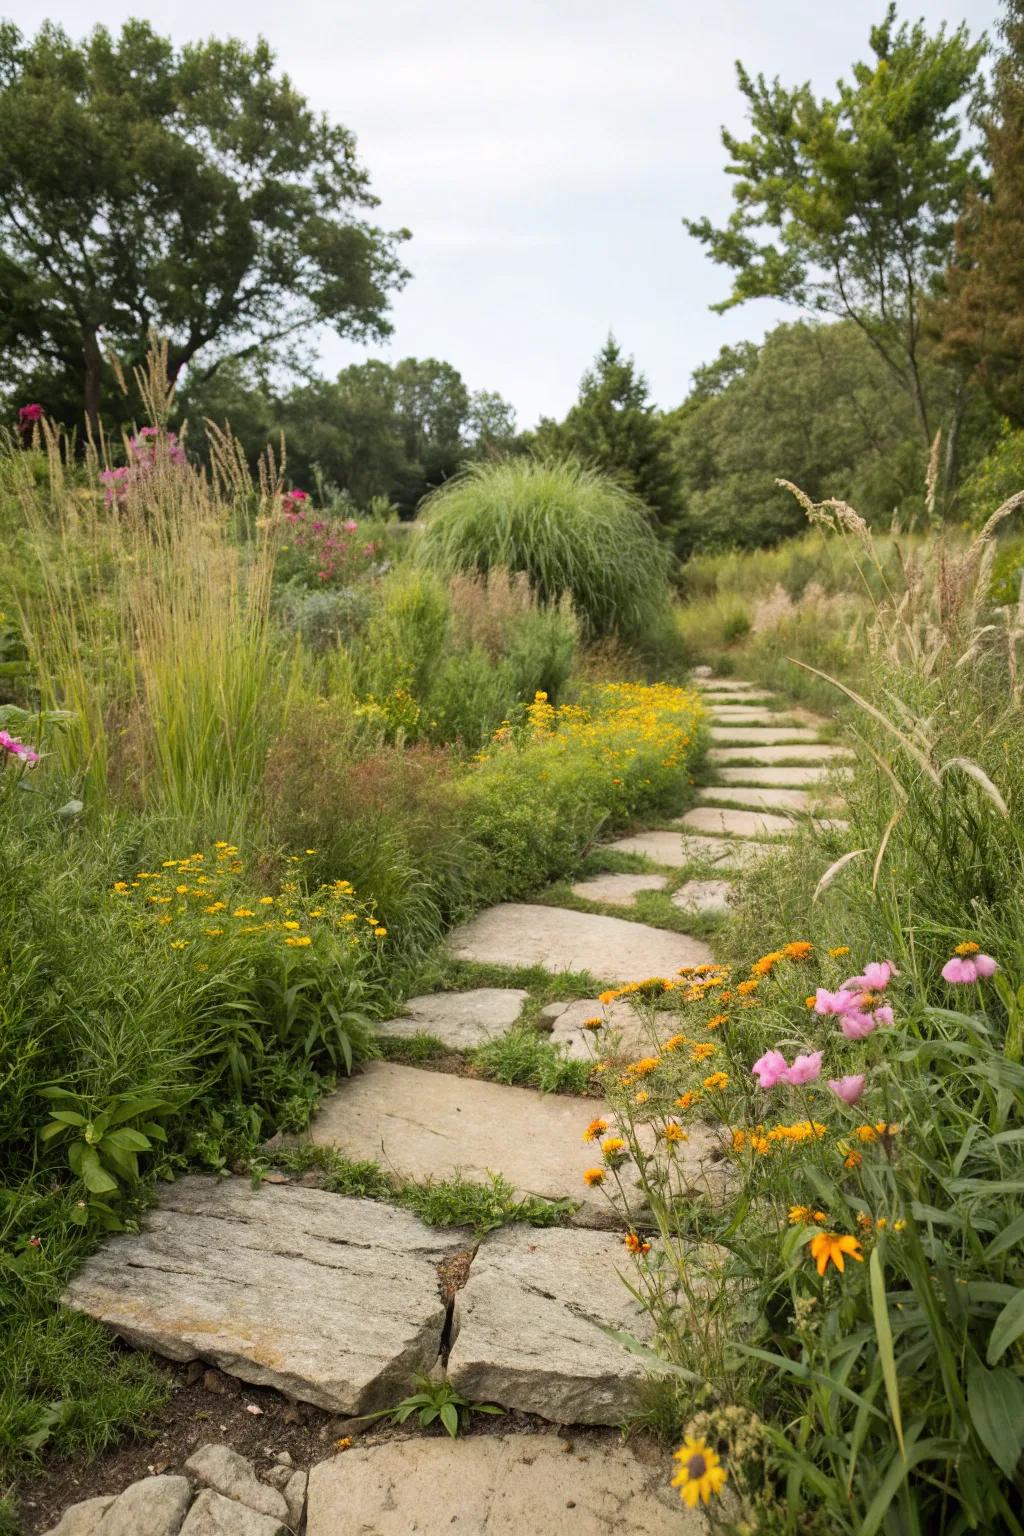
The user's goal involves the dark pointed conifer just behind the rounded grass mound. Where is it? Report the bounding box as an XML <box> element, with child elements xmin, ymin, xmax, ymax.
<box><xmin>536</xmin><ymin>335</ymin><xmax>679</xmax><ymax>530</ymax></box>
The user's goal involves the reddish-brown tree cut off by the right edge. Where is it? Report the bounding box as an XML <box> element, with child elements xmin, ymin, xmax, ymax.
<box><xmin>936</xmin><ymin>0</ymin><xmax>1024</xmax><ymax>427</ymax></box>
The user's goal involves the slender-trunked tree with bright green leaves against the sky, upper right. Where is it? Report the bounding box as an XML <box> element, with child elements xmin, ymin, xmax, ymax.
<box><xmin>685</xmin><ymin>5</ymin><xmax>984</xmax><ymax>444</ymax></box>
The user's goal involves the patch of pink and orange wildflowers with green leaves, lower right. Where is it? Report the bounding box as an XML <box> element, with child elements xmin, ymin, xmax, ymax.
<box><xmin>582</xmin><ymin>938</ymin><xmax>1024</xmax><ymax>1536</ymax></box>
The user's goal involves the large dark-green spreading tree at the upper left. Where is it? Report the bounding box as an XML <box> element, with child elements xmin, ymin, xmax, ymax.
<box><xmin>0</xmin><ymin>20</ymin><xmax>407</xmax><ymax>430</ymax></box>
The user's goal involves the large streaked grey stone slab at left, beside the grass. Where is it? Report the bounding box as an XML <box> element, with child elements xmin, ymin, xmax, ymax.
<box><xmin>63</xmin><ymin>1173</ymin><xmax>466</xmax><ymax>1413</ymax></box>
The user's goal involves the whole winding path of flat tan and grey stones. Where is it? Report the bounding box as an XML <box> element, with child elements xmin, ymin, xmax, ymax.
<box><xmin>57</xmin><ymin>676</ymin><xmax>851</xmax><ymax>1536</ymax></box>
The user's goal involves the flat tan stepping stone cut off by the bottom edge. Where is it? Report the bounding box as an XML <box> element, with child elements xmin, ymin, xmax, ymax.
<box><xmin>306</xmin><ymin>1435</ymin><xmax>708</xmax><ymax>1536</ymax></box>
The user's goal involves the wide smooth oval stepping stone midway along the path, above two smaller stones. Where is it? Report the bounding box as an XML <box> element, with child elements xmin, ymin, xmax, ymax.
<box><xmin>448</xmin><ymin>897</ymin><xmax>714</xmax><ymax>982</ymax></box>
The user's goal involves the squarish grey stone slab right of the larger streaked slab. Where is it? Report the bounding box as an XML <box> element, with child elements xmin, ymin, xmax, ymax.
<box><xmin>448</xmin><ymin>1227</ymin><xmax>654</xmax><ymax>1424</ymax></box>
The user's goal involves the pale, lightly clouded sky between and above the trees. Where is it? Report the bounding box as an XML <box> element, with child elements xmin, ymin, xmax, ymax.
<box><xmin>17</xmin><ymin>0</ymin><xmax>998</xmax><ymax>427</ymax></box>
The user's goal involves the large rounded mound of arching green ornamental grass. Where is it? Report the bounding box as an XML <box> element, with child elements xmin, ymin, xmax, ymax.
<box><xmin>416</xmin><ymin>459</ymin><xmax>666</xmax><ymax>637</ymax></box>
